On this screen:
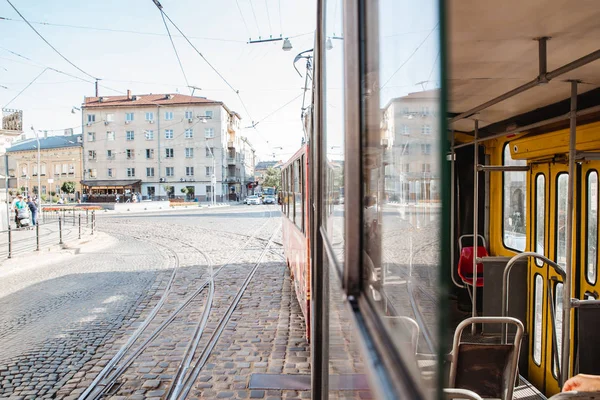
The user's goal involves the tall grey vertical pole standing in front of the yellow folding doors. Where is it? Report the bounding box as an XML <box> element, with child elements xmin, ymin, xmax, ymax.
<box><xmin>559</xmin><ymin>81</ymin><xmax>577</xmax><ymax>387</ymax></box>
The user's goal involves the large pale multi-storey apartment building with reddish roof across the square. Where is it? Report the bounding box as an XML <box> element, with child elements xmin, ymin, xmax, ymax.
<box><xmin>82</xmin><ymin>91</ymin><xmax>254</xmax><ymax>201</ymax></box>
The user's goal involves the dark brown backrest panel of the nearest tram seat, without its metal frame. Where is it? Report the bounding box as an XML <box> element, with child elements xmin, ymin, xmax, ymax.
<box><xmin>454</xmin><ymin>343</ymin><xmax>515</xmax><ymax>398</ymax></box>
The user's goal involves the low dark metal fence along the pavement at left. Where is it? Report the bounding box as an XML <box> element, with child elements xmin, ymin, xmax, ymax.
<box><xmin>0</xmin><ymin>210</ymin><xmax>96</xmax><ymax>259</ymax></box>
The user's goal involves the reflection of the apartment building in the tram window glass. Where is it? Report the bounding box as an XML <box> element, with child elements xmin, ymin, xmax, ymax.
<box><xmin>382</xmin><ymin>91</ymin><xmax>440</xmax><ymax>203</ymax></box>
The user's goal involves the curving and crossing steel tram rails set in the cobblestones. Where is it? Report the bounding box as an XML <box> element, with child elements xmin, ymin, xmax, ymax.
<box><xmin>79</xmin><ymin>205</ymin><xmax>277</xmax><ymax>400</ymax></box>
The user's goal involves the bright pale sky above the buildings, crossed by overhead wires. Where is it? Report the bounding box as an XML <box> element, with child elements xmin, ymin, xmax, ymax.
<box><xmin>0</xmin><ymin>0</ymin><xmax>315</xmax><ymax>160</ymax></box>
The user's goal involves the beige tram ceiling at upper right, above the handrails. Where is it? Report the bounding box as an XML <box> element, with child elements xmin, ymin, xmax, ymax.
<box><xmin>449</xmin><ymin>0</ymin><xmax>600</xmax><ymax>136</ymax></box>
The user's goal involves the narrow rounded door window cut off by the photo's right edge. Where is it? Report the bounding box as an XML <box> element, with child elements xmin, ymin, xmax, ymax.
<box><xmin>585</xmin><ymin>171</ymin><xmax>598</xmax><ymax>285</ymax></box>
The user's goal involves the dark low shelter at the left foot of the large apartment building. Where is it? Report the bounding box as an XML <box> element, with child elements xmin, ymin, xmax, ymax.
<box><xmin>81</xmin><ymin>179</ymin><xmax>142</xmax><ymax>203</ymax></box>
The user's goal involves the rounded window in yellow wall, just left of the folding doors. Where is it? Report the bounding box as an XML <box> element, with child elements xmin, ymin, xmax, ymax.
<box><xmin>502</xmin><ymin>143</ymin><xmax>527</xmax><ymax>251</ymax></box>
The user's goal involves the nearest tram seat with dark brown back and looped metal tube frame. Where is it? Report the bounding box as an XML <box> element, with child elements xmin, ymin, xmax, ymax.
<box><xmin>449</xmin><ymin>317</ymin><xmax>524</xmax><ymax>400</ymax></box>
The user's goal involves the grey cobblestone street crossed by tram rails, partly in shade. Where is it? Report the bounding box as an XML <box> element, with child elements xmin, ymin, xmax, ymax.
<box><xmin>0</xmin><ymin>206</ymin><xmax>310</xmax><ymax>399</ymax></box>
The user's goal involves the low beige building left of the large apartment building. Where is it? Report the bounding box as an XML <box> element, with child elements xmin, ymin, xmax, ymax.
<box><xmin>6</xmin><ymin>134</ymin><xmax>83</xmax><ymax>200</ymax></box>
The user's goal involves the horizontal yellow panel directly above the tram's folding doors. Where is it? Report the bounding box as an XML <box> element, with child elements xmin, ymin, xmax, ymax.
<box><xmin>510</xmin><ymin>122</ymin><xmax>600</xmax><ymax>160</ymax></box>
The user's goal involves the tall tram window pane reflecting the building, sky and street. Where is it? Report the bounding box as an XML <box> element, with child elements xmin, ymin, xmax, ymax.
<box><xmin>370</xmin><ymin>0</ymin><xmax>441</xmax><ymax>389</ymax></box>
